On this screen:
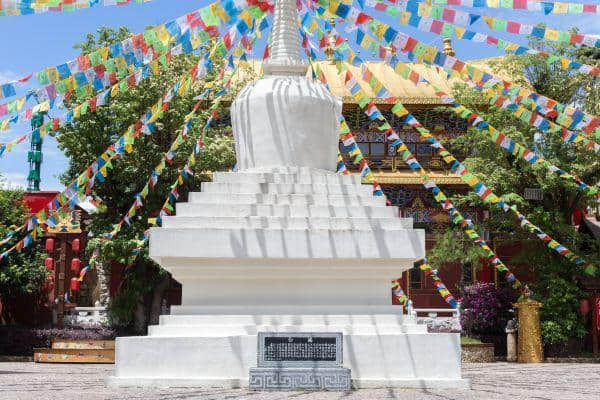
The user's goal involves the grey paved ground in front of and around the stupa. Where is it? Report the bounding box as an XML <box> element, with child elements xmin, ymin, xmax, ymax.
<box><xmin>0</xmin><ymin>363</ymin><xmax>600</xmax><ymax>400</ymax></box>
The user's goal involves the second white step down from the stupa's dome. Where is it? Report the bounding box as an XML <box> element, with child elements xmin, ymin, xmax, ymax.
<box><xmin>201</xmin><ymin>182</ymin><xmax>373</xmax><ymax>197</ymax></box>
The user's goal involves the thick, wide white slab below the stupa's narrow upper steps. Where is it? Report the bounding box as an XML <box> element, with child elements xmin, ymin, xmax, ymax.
<box><xmin>150</xmin><ymin>228</ymin><xmax>425</xmax><ymax>260</ymax></box>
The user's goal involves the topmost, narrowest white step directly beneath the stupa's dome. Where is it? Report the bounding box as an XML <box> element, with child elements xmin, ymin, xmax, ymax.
<box><xmin>213</xmin><ymin>172</ymin><xmax>362</xmax><ymax>185</ymax></box>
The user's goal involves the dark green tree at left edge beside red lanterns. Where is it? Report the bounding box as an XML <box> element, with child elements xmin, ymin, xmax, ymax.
<box><xmin>0</xmin><ymin>176</ymin><xmax>47</xmax><ymax>324</ymax></box>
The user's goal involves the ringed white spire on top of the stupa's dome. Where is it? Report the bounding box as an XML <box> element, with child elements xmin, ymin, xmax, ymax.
<box><xmin>263</xmin><ymin>0</ymin><xmax>308</xmax><ymax>76</ymax></box>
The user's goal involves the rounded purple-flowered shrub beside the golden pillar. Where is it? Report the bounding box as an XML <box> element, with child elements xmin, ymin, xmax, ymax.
<box><xmin>460</xmin><ymin>283</ymin><xmax>516</xmax><ymax>337</ymax></box>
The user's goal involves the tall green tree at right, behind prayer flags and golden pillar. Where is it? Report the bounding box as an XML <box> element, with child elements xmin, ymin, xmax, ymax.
<box><xmin>429</xmin><ymin>35</ymin><xmax>600</xmax><ymax>342</ymax></box>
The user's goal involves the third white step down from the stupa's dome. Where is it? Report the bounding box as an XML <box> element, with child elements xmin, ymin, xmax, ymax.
<box><xmin>188</xmin><ymin>192</ymin><xmax>385</xmax><ymax>207</ymax></box>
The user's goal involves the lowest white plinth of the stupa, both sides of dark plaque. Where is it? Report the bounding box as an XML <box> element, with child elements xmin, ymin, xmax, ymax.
<box><xmin>111</xmin><ymin>332</ymin><xmax>468</xmax><ymax>387</ymax></box>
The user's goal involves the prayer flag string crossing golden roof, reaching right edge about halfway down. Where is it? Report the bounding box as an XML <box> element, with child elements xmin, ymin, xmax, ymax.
<box><xmin>354</xmin><ymin>25</ymin><xmax>600</xmax><ymax>197</ymax></box>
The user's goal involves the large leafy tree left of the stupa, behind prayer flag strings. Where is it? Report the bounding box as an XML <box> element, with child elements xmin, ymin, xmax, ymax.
<box><xmin>57</xmin><ymin>28</ymin><xmax>250</xmax><ymax>331</ymax></box>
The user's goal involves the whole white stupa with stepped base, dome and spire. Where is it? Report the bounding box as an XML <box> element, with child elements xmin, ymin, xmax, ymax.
<box><xmin>110</xmin><ymin>0</ymin><xmax>467</xmax><ymax>387</ymax></box>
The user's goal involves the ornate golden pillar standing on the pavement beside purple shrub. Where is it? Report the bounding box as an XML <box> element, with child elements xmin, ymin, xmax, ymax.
<box><xmin>515</xmin><ymin>288</ymin><xmax>544</xmax><ymax>363</ymax></box>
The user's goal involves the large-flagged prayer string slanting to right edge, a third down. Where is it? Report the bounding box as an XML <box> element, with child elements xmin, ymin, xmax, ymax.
<box><xmin>318</xmin><ymin>0</ymin><xmax>600</xmax><ymax>133</ymax></box>
